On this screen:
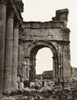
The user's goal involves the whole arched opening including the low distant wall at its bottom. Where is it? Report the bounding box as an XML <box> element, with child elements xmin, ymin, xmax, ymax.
<box><xmin>35</xmin><ymin>47</ymin><xmax>53</xmax><ymax>80</ymax></box>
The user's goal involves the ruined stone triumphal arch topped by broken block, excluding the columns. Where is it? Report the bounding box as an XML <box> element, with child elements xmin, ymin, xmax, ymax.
<box><xmin>19</xmin><ymin>9</ymin><xmax>70</xmax><ymax>82</ymax></box>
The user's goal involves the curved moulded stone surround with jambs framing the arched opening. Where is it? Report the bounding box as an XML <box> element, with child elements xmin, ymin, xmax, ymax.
<box><xmin>20</xmin><ymin>40</ymin><xmax>58</xmax><ymax>81</ymax></box>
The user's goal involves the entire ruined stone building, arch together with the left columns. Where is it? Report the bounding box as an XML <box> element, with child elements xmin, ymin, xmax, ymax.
<box><xmin>0</xmin><ymin>0</ymin><xmax>71</xmax><ymax>100</ymax></box>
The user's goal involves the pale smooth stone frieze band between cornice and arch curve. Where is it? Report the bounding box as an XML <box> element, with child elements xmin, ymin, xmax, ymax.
<box><xmin>21</xmin><ymin>28</ymin><xmax>69</xmax><ymax>41</ymax></box>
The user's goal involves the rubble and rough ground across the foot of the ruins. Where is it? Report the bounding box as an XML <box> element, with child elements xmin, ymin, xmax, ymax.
<box><xmin>3</xmin><ymin>81</ymin><xmax>77</xmax><ymax>100</ymax></box>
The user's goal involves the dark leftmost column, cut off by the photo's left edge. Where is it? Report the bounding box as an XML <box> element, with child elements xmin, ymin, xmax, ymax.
<box><xmin>0</xmin><ymin>1</ymin><xmax>6</xmax><ymax>100</ymax></box>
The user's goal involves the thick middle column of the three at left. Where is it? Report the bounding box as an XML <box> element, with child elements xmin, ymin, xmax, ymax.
<box><xmin>4</xmin><ymin>12</ymin><xmax>14</xmax><ymax>92</ymax></box>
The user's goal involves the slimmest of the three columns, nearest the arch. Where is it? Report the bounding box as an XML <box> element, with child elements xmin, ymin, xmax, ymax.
<box><xmin>12</xmin><ymin>23</ymin><xmax>19</xmax><ymax>90</ymax></box>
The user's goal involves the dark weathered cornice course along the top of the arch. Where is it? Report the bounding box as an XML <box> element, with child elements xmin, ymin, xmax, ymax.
<box><xmin>23</xmin><ymin>21</ymin><xmax>64</xmax><ymax>29</ymax></box>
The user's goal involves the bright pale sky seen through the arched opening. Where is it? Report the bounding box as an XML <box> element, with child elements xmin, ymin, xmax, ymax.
<box><xmin>36</xmin><ymin>47</ymin><xmax>53</xmax><ymax>74</ymax></box>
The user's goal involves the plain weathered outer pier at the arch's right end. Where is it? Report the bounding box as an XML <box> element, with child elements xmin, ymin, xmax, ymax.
<box><xmin>63</xmin><ymin>43</ymin><xmax>71</xmax><ymax>83</ymax></box>
